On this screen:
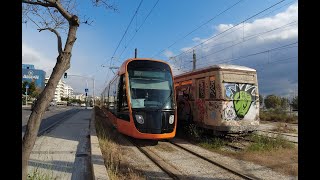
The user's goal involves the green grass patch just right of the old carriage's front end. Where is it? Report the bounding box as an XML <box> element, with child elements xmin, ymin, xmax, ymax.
<box><xmin>246</xmin><ymin>134</ymin><xmax>294</xmax><ymax>152</ymax></box>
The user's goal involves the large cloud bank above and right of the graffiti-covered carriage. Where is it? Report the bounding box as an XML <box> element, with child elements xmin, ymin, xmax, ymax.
<box><xmin>176</xmin><ymin>3</ymin><xmax>298</xmax><ymax>96</ymax></box>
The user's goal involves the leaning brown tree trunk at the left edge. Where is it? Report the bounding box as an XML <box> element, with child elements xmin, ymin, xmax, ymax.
<box><xmin>22</xmin><ymin>22</ymin><xmax>79</xmax><ymax>180</ymax></box>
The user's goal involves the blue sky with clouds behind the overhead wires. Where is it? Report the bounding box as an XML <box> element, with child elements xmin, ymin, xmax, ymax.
<box><xmin>22</xmin><ymin>0</ymin><xmax>298</xmax><ymax>96</ymax></box>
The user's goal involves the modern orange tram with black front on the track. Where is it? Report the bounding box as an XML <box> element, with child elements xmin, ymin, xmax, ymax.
<box><xmin>101</xmin><ymin>58</ymin><xmax>177</xmax><ymax>140</ymax></box>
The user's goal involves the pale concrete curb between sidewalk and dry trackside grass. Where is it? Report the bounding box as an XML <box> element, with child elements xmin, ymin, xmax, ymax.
<box><xmin>90</xmin><ymin>108</ymin><xmax>109</xmax><ymax>180</ymax></box>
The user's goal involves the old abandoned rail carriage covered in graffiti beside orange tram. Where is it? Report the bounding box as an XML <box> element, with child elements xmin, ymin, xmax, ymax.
<box><xmin>174</xmin><ymin>64</ymin><xmax>259</xmax><ymax>134</ymax></box>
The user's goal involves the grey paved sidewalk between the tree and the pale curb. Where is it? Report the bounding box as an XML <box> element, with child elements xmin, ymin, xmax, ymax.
<box><xmin>29</xmin><ymin>109</ymin><xmax>93</xmax><ymax>180</ymax></box>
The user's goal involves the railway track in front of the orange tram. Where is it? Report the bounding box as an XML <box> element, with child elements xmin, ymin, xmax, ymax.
<box><xmin>128</xmin><ymin>138</ymin><xmax>259</xmax><ymax>180</ymax></box>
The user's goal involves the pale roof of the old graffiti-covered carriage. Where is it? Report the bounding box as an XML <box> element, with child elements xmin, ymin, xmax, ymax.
<box><xmin>175</xmin><ymin>64</ymin><xmax>256</xmax><ymax>77</ymax></box>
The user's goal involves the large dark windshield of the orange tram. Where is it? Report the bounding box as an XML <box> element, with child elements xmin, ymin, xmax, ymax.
<box><xmin>128</xmin><ymin>61</ymin><xmax>174</xmax><ymax>109</ymax></box>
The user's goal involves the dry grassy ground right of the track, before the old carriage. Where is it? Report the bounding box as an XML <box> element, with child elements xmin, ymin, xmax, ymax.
<box><xmin>185</xmin><ymin>130</ymin><xmax>298</xmax><ymax>176</ymax></box>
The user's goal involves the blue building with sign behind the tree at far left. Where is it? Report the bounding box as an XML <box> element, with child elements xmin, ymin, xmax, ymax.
<box><xmin>22</xmin><ymin>64</ymin><xmax>46</xmax><ymax>89</ymax></box>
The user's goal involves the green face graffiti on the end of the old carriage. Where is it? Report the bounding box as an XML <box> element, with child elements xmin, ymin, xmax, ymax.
<box><xmin>225</xmin><ymin>83</ymin><xmax>256</xmax><ymax>119</ymax></box>
